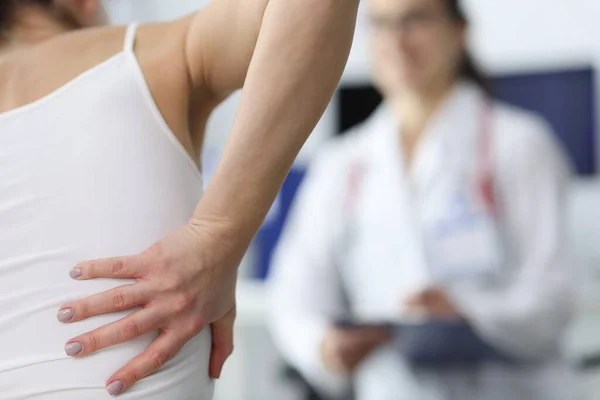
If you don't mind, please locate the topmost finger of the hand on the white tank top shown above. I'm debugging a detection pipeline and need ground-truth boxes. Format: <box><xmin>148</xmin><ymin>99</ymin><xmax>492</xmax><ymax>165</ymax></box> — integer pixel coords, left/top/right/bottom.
<box><xmin>69</xmin><ymin>253</ymin><xmax>148</xmax><ymax>280</ymax></box>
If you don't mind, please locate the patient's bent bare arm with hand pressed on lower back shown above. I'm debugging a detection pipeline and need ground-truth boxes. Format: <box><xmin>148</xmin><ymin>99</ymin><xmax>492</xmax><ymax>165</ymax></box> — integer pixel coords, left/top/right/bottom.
<box><xmin>61</xmin><ymin>0</ymin><xmax>359</xmax><ymax>393</ymax></box>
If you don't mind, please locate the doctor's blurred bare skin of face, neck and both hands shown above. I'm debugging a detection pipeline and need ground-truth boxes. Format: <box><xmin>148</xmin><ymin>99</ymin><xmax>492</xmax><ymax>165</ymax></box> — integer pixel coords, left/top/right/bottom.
<box><xmin>321</xmin><ymin>0</ymin><xmax>466</xmax><ymax>374</ymax></box>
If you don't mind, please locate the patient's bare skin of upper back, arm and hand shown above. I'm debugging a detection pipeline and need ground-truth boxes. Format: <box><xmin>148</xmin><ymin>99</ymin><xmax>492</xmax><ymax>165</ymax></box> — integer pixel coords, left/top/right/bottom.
<box><xmin>0</xmin><ymin>0</ymin><xmax>358</xmax><ymax>394</ymax></box>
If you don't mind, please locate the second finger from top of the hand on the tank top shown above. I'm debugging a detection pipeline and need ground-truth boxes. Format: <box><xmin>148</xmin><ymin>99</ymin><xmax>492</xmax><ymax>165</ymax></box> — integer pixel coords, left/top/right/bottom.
<box><xmin>57</xmin><ymin>283</ymin><xmax>154</xmax><ymax>323</ymax></box>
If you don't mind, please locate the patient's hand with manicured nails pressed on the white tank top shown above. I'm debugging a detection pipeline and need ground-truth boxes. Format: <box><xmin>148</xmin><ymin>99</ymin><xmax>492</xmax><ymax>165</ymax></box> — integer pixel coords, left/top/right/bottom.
<box><xmin>58</xmin><ymin>220</ymin><xmax>244</xmax><ymax>395</ymax></box>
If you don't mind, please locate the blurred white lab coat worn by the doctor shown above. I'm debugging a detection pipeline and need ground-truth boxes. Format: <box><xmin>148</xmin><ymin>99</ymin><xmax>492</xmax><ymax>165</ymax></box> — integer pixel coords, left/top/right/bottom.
<box><xmin>269</xmin><ymin>82</ymin><xmax>579</xmax><ymax>400</ymax></box>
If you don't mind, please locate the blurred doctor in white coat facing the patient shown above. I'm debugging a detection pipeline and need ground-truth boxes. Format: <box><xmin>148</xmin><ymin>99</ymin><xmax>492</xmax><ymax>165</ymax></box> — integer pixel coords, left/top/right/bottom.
<box><xmin>270</xmin><ymin>0</ymin><xmax>578</xmax><ymax>400</ymax></box>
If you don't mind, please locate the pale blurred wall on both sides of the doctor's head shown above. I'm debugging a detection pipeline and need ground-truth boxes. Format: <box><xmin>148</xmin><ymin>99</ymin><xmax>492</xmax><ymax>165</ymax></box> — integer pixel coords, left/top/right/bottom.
<box><xmin>346</xmin><ymin>0</ymin><xmax>600</xmax><ymax>81</ymax></box>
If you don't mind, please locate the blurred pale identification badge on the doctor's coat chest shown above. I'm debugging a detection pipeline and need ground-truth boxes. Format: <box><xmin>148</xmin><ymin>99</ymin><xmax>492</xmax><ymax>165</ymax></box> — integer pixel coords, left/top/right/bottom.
<box><xmin>427</xmin><ymin>194</ymin><xmax>502</xmax><ymax>280</ymax></box>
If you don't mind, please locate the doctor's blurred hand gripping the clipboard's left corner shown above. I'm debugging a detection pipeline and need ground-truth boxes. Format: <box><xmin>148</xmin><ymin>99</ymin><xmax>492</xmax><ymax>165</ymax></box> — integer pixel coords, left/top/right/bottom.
<box><xmin>321</xmin><ymin>327</ymin><xmax>391</xmax><ymax>374</ymax></box>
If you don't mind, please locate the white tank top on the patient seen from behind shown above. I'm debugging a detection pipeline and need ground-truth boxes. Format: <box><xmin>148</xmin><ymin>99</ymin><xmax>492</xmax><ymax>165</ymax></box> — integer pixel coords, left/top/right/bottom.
<box><xmin>0</xmin><ymin>25</ymin><xmax>213</xmax><ymax>400</ymax></box>
